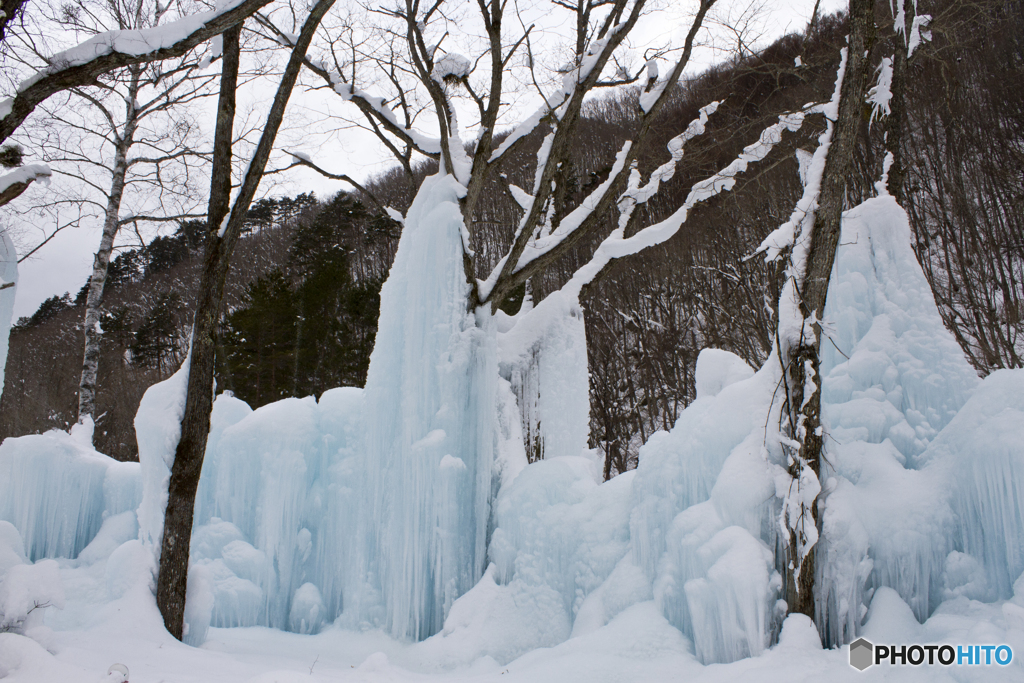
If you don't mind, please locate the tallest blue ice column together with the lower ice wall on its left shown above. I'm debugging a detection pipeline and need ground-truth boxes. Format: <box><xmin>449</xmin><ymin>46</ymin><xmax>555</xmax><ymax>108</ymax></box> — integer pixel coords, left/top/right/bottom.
<box><xmin>193</xmin><ymin>177</ymin><xmax>499</xmax><ymax>640</ymax></box>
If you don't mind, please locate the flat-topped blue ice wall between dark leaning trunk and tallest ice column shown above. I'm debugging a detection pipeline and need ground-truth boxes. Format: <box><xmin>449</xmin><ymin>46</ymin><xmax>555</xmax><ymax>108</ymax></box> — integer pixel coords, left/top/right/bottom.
<box><xmin>191</xmin><ymin>387</ymin><xmax>364</xmax><ymax>633</ymax></box>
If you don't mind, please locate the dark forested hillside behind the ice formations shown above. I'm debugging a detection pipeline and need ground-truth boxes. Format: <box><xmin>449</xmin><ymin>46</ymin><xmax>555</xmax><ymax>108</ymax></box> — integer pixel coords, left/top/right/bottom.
<box><xmin>0</xmin><ymin>0</ymin><xmax>1024</xmax><ymax>477</ymax></box>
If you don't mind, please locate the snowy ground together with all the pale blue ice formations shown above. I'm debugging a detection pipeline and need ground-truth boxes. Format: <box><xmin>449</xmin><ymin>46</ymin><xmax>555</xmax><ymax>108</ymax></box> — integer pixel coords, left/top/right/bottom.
<box><xmin>0</xmin><ymin>189</ymin><xmax>1024</xmax><ymax>683</ymax></box>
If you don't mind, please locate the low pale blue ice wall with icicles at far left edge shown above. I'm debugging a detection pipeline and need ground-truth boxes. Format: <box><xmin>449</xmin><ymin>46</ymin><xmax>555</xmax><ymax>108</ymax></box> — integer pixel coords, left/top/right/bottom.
<box><xmin>0</xmin><ymin>430</ymin><xmax>141</xmax><ymax>561</ymax></box>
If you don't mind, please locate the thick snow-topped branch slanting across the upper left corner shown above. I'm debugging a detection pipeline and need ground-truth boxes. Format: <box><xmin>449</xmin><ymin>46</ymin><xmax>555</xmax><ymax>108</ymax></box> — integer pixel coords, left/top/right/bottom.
<box><xmin>0</xmin><ymin>0</ymin><xmax>270</xmax><ymax>147</ymax></box>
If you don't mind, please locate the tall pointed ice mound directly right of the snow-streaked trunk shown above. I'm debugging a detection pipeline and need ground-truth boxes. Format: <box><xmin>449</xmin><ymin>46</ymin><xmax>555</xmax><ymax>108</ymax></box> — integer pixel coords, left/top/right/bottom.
<box><xmin>818</xmin><ymin>196</ymin><xmax>979</xmax><ymax>643</ymax></box>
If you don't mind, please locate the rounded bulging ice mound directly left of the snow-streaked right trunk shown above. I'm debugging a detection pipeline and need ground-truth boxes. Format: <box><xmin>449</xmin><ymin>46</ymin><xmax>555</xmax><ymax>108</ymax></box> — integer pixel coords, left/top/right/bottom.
<box><xmin>630</xmin><ymin>349</ymin><xmax>781</xmax><ymax>663</ymax></box>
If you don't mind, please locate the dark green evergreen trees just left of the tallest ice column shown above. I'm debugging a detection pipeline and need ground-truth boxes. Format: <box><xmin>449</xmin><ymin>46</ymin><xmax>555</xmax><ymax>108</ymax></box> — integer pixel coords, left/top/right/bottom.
<box><xmin>220</xmin><ymin>194</ymin><xmax>385</xmax><ymax>405</ymax></box>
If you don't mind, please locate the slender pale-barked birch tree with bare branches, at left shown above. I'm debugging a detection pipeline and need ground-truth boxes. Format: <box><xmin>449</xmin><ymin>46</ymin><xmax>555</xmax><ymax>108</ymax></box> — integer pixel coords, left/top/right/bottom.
<box><xmin>9</xmin><ymin>0</ymin><xmax>222</xmax><ymax>434</ymax></box>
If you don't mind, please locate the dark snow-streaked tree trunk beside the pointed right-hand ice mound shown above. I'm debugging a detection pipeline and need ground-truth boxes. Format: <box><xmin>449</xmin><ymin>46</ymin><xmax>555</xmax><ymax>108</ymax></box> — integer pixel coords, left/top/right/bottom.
<box><xmin>786</xmin><ymin>0</ymin><xmax>874</xmax><ymax>618</ymax></box>
